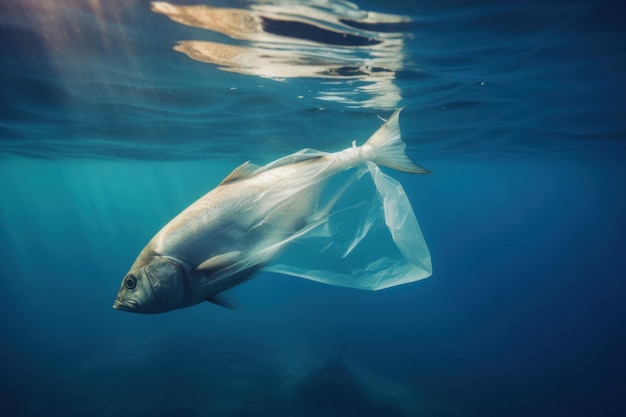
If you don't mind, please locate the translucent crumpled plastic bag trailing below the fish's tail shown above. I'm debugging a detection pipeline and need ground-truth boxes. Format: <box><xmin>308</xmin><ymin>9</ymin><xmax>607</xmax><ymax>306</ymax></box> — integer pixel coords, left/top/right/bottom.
<box><xmin>264</xmin><ymin>162</ymin><xmax>432</xmax><ymax>290</ymax></box>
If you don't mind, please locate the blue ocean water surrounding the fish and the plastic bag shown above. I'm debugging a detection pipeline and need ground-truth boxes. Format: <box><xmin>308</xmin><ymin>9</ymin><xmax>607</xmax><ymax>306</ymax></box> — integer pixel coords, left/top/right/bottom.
<box><xmin>0</xmin><ymin>0</ymin><xmax>626</xmax><ymax>417</ymax></box>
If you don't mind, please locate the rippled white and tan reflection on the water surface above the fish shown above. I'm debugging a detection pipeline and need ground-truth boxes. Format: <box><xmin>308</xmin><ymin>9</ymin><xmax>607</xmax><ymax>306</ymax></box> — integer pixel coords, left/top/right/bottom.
<box><xmin>152</xmin><ymin>0</ymin><xmax>411</xmax><ymax>109</ymax></box>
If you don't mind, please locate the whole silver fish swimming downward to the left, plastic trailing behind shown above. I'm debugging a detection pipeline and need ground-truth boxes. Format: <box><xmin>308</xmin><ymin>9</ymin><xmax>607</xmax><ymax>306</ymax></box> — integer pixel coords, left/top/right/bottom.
<box><xmin>113</xmin><ymin>109</ymin><xmax>430</xmax><ymax>314</ymax></box>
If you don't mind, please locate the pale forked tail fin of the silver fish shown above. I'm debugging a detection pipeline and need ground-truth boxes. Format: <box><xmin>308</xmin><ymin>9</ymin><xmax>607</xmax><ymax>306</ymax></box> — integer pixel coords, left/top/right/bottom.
<box><xmin>363</xmin><ymin>108</ymin><xmax>430</xmax><ymax>174</ymax></box>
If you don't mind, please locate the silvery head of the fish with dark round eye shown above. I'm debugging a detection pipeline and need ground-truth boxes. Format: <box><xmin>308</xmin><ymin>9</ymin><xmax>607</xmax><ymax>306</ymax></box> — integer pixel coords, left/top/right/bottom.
<box><xmin>113</xmin><ymin>255</ymin><xmax>186</xmax><ymax>314</ymax></box>
